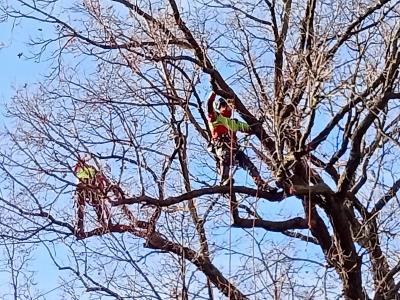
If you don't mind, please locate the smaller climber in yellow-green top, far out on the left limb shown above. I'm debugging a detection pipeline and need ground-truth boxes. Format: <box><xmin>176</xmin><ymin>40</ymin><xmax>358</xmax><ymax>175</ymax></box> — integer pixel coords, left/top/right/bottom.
<box><xmin>74</xmin><ymin>158</ymin><xmax>111</xmax><ymax>238</ymax></box>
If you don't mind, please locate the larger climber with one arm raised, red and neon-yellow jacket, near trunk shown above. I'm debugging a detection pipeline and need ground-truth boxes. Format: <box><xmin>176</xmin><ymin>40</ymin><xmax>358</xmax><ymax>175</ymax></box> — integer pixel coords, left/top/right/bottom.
<box><xmin>207</xmin><ymin>91</ymin><xmax>276</xmax><ymax>192</ymax></box>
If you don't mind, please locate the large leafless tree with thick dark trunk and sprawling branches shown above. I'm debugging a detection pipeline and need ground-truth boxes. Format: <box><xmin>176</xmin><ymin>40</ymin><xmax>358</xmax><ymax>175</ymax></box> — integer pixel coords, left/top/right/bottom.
<box><xmin>0</xmin><ymin>0</ymin><xmax>400</xmax><ymax>300</ymax></box>
